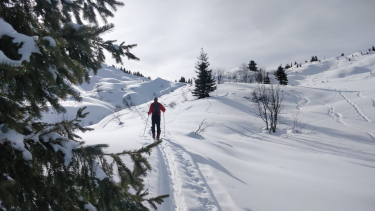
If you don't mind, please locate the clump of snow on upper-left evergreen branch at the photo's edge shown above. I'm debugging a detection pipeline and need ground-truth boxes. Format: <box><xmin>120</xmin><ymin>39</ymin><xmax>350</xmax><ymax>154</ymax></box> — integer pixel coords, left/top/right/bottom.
<box><xmin>0</xmin><ymin>18</ymin><xmax>40</xmax><ymax>67</ymax></box>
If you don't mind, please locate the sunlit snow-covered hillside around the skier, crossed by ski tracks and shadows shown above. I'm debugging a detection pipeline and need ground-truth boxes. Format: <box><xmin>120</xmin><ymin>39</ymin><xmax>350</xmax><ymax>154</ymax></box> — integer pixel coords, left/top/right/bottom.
<box><xmin>69</xmin><ymin>53</ymin><xmax>375</xmax><ymax>211</ymax></box>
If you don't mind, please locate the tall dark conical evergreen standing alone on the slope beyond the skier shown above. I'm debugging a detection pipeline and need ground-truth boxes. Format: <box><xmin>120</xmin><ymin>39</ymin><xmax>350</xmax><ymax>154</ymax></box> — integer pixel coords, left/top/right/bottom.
<box><xmin>193</xmin><ymin>48</ymin><xmax>216</xmax><ymax>99</ymax></box>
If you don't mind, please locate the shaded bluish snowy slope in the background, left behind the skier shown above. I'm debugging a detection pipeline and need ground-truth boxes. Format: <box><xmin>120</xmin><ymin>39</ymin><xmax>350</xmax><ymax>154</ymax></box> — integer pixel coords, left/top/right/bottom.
<box><xmin>44</xmin><ymin>64</ymin><xmax>183</xmax><ymax>126</ymax></box>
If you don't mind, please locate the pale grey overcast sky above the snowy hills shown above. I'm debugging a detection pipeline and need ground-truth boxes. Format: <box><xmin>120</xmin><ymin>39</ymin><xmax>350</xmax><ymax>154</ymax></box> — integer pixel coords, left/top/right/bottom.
<box><xmin>105</xmin><ymin>0</ymin><xmax>375</xmax><ymax>81</ymax></box>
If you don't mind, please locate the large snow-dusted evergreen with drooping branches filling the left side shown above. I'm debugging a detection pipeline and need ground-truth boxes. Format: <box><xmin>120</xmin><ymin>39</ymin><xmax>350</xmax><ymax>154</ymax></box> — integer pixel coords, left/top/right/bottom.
<box><xmin>0</xmin><ymin>0</ymin><xmax>167</xmax><ymax>211</ymax></box>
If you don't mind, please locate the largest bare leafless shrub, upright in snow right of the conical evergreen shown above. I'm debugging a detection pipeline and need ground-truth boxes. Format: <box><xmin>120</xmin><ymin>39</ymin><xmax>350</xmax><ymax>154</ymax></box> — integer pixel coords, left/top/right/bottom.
<box><xmin>251</xmin><ymin>84</ymin><xmax>284</xmax><ymax>133</ymax></box>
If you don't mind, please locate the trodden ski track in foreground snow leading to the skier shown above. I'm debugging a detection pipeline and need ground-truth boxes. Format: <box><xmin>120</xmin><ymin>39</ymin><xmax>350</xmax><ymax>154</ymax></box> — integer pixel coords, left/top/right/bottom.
<box><xmin>159</xmin><ymin>139</ymin><xmax>221</xmax><ymax>211</ymax></box>
